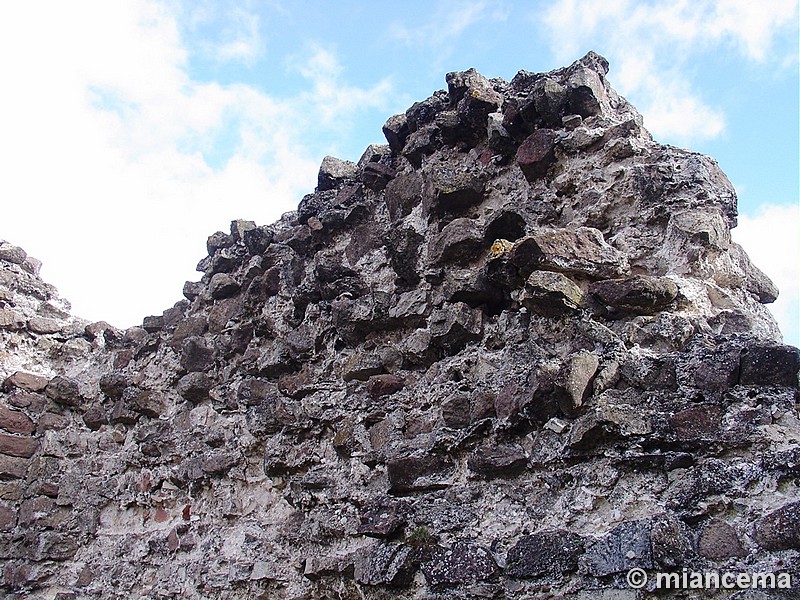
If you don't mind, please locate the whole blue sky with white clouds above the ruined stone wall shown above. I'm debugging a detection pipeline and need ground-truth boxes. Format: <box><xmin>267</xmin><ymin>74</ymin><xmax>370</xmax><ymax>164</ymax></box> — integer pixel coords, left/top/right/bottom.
<box><xmin>0</xmin><ymin>0</ymin><xmax>800</xmax><ymax>344</ymax></box>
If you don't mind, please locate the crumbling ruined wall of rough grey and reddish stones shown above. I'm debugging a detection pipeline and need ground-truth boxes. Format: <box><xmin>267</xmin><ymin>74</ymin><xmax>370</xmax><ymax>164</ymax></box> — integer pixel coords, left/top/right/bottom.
<box><xmin>0</xmin><ymin>53</ymin><xmax>800</xmax><ymax>600</ymax></box>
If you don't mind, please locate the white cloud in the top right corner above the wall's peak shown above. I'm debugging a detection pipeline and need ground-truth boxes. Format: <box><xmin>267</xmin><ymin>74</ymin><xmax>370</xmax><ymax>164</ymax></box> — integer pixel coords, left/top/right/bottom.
<box><xmin>531</xmin><ymin>0</ymin><xmax>797</xmax><ymax>143</ymax></box>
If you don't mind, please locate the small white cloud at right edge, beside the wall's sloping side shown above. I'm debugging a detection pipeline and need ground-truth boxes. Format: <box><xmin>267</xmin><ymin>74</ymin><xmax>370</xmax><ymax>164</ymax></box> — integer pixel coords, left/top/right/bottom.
<box><xmin>731</xmin><ymin>204</ymin><xmax>800</xmax><ymax>346</ymax></box>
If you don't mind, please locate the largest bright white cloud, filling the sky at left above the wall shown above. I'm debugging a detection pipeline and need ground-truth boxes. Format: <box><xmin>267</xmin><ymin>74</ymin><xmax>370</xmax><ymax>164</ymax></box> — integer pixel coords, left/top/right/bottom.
<box><xmin>0</xmin><ymin>0</ymin><xmax>390</xmax><ymax>326</ymax></box>
